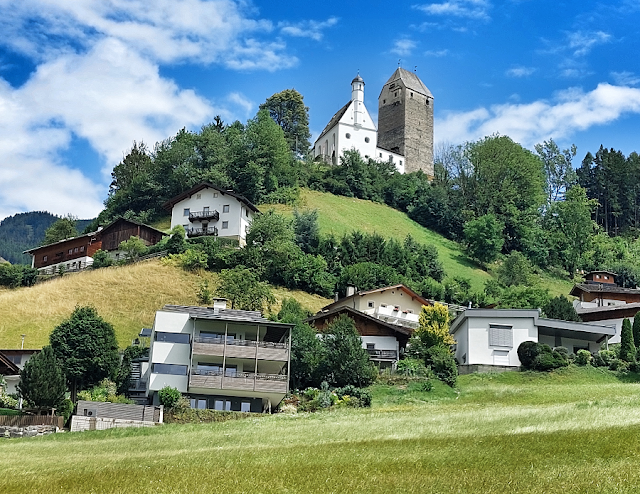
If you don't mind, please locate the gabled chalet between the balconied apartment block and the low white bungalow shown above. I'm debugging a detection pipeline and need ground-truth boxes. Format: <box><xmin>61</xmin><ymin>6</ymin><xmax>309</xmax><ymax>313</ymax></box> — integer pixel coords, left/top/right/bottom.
<box><xmin>307</xmin><ymin>285</ymin><xmax>431</xmax><ymax>367</ymax></box>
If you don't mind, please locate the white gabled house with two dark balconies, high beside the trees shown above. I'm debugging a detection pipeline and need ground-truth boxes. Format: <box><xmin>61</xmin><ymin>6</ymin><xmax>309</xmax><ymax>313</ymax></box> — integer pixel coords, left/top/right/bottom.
<box><xmin>163</xmin><ymin>182</ymin><xmax>260</xmax><ymax>247</ymax></box>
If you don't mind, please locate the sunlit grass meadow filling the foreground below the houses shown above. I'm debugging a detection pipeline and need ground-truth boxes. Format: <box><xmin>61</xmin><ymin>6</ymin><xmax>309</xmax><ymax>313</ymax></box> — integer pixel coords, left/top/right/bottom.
<box><xmin>0</xmin><ymin>368</ymin><xmax>640</xmax><ymax>494</ymax></box>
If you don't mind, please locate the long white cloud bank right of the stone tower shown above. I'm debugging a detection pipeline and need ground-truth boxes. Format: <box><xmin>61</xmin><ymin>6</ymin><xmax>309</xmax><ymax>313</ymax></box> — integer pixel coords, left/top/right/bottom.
<box><xmin>435</xmin><ymin>83</ymin><xmax>640</xmax><ymax>147</ymax></box>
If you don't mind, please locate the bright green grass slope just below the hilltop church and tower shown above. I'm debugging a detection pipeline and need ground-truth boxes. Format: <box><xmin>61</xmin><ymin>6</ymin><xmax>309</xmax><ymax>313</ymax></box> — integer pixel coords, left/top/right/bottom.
<box><xmin>260</xmin><ymin>190</ymin><xmax>572</xmax><ymax>296</ymax></box>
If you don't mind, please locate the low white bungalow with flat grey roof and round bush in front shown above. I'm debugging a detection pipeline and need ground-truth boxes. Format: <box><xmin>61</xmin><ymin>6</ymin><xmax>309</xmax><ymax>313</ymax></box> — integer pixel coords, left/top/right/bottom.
<box><xmin>450</xmin><ymin>309</ymin><xmax>616</xmax><ymax>374</ymax></box>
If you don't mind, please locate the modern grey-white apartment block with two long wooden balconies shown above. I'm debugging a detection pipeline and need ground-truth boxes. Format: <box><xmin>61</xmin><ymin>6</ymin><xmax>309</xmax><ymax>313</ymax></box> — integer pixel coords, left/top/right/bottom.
<box><xmin>142</xmin><ymin>300</ymin><xmax>293</xmax><ymax>413</ymax></box>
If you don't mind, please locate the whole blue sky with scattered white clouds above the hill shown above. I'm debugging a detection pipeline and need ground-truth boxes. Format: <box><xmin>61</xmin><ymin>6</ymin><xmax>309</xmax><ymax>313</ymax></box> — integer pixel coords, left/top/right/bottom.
<box><xmin>0</xmin><ymin>0</ymin><xmax>640</xmax><ymax>218</ymax></box>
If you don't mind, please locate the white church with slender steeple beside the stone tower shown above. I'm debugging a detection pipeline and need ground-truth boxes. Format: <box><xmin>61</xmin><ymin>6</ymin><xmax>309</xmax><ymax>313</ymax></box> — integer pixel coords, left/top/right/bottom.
<box><xmin>313</xmin><ymin>76</ymin><xmax>404</xmax><ymax>173</ymax></box>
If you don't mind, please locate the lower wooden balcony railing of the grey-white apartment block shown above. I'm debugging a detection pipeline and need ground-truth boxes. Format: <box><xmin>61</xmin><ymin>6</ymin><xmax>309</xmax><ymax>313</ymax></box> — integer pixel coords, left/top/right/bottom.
<box><xmin>189</xmin><ymin>370</ymin><xmax>289</xmax><ymax>393</ymax></box>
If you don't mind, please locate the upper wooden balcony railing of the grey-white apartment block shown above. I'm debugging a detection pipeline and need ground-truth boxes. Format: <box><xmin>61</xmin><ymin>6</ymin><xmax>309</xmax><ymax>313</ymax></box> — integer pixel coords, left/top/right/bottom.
<box><xmin>193</xmin><ymin>337</ymin><xmax>289</xmax><ymax>362</ymax></box>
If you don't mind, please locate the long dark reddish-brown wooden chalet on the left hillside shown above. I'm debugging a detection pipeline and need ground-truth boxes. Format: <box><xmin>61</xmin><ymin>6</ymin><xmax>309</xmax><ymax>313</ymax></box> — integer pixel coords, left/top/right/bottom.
<box><xmin>25</xmin><ymin>218</ymin><xmax>164</xmax><ymax>274</ymax></box>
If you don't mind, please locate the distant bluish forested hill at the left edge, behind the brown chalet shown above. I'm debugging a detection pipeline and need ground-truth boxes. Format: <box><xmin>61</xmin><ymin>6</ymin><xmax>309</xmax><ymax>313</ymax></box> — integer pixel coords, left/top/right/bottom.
<box><xmin>0</xmin><ymin>211</ymin><xmax>91</xmax><ymax>264</ymax></box>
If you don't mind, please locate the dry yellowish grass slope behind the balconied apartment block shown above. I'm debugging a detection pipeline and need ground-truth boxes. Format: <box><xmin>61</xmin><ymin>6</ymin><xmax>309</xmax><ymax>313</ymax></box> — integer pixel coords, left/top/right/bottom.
<box><xmin>0</xmin><ymin>260</ymin><xmax>329</xmax><ymax>348</ymax></box>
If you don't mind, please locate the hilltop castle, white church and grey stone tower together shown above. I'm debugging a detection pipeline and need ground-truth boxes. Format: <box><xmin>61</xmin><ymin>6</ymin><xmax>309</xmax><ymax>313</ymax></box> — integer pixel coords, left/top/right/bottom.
<box><xmin>313</xmin><ymin>68</ymin><xmax>433</xmax><ymax>177</ymax></box>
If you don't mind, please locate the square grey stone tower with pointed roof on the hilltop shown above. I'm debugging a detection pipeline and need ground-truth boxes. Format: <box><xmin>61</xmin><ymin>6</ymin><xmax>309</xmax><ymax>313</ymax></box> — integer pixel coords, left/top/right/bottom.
<box><xmin>378</xmin><ymin>68</ymin><xmax>433</xmax><ymax>177</ymax></box>
